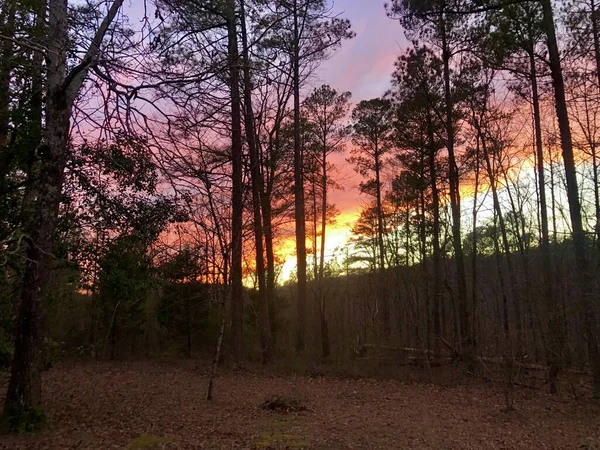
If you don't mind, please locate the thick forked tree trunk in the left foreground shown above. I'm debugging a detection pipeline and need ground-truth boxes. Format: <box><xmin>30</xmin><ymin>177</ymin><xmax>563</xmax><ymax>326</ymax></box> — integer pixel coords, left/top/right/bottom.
<box><xmin>4</xmin><ymin>0</ymin><xmax>123</xmax><ymax>427</ymax></box>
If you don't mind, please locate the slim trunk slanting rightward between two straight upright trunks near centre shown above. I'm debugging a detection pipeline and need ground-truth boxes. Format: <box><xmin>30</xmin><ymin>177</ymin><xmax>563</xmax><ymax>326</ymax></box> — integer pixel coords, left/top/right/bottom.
<box><xmin>240</xmin><ymin>0</ymin><xmax>272</xmax><ymax>364</ymax></box>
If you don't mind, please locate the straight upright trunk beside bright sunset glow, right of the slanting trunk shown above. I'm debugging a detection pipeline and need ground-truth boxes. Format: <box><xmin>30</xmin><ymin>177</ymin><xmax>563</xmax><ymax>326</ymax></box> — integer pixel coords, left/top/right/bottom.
<box><xmin>293</xmin><ymin>0</ymin><xmax>306</xmax><ymax>353</ymax></box>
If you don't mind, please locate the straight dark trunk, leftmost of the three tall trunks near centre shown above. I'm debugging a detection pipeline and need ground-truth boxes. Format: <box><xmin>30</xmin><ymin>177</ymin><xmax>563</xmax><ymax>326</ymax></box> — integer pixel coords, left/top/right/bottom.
<box><xmin>227</xmin><ymin>0</ymin><xmax>244</xmax><ymax>367</ymax></box>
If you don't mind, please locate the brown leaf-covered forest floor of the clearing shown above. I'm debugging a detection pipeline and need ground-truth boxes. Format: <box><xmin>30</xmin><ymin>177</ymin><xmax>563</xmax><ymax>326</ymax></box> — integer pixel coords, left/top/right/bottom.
<box><xmin>0</xmin><ymin>361</ymin><xmax>600</xmax><ymax>450</ymax></box>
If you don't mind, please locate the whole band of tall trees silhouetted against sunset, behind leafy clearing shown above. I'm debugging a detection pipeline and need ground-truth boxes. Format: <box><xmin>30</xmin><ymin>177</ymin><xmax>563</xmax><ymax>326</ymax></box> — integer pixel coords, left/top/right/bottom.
<box><xmin>0</xmin><ymin>0</ymin><xmax>600</xmax><ymax>430</ymax></box>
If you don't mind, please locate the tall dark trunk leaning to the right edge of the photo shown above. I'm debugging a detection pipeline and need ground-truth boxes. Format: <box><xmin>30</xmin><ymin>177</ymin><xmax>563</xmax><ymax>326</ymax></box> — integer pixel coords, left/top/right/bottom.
<box><xmin>541</xmin><ymin>0</ymin><xmax>600</xmax><ymax>397</ymax></box>
